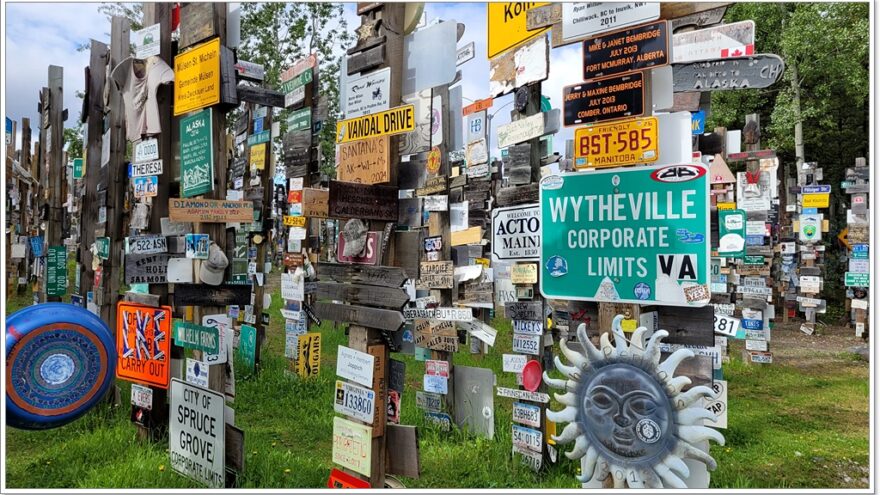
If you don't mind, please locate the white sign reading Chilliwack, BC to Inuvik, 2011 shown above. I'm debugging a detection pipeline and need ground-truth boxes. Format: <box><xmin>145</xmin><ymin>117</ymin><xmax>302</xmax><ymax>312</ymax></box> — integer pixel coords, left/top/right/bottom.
<box><xmin>562</xmin><ymin>2</ymin><xmax>660</xmax><ymax>42</ymax></box>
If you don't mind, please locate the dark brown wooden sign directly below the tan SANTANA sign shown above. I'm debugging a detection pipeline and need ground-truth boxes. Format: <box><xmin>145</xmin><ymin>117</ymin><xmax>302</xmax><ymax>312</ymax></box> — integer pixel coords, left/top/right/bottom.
<box><xmin>329</xmin><ymin>180</ymin><xmax>398</xmax><ymax>222</ymax></box>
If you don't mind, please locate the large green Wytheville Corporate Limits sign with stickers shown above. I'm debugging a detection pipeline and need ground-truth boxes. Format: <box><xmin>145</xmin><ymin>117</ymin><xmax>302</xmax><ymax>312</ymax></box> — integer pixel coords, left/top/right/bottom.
<box><xmin>540</xmin><ymin>164</ymin><xmax>710</xmax><ymax>306</ymax></box>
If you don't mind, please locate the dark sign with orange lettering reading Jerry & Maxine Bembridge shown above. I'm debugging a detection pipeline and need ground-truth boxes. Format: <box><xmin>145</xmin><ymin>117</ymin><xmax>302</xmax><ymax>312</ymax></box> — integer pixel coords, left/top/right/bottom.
<box><xmin>562</xmin><ymin>72</ymin><xmax>645</xmax><ymax>127</ymax></box>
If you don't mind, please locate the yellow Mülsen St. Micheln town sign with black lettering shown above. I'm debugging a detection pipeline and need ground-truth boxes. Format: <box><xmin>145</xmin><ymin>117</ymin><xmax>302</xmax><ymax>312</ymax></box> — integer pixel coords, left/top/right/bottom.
<box><xmin>174</xmin><ymin>38</ymin><xmax>220</xmax><ymax>115</ymax></box>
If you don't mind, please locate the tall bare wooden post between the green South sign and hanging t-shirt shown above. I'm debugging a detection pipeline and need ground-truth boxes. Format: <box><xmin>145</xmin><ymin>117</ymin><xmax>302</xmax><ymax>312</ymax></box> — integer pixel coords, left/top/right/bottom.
<box><xmin>79</xmin><ymin>40</ymin><xmax>110</xmax><ymax>310</ymax></box>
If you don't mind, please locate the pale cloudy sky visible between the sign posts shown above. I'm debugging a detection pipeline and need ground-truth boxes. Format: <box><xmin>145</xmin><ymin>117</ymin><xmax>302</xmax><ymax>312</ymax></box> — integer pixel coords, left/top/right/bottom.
<box><xmin>4</xmin><ymin>3</ymin><xmax>581</xmax><ymax>156</ymax></box>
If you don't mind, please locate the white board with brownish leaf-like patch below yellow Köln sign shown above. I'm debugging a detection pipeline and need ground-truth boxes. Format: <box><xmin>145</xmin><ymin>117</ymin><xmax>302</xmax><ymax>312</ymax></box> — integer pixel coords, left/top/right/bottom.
<box><xmin>489</xmin><ymin>36</ymin><xmax>550</xmax><ymax>98</ymax></box>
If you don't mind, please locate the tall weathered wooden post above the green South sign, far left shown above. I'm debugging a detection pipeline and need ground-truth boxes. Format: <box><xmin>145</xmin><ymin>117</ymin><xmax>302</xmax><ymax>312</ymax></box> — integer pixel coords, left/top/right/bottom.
<box><xmin>43</xmin><ymin>65</ymin><xmax>64</xmax><ymax>302</ymax></box>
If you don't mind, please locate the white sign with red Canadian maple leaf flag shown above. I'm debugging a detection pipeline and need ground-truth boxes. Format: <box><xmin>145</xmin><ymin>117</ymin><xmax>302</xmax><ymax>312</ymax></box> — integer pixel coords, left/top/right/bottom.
<box><xmin>672</xmin><ymin>20</ymin><xmax>755</xmax><ymax>63</ymax></box>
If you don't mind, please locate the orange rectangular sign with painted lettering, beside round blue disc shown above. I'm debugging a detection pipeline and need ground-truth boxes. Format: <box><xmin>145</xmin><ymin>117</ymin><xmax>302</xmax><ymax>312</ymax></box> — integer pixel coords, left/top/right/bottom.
<box><xmin>116</xmin><ymin>302</ymin><xmax>171</xmax><ymax>389</ymax></box>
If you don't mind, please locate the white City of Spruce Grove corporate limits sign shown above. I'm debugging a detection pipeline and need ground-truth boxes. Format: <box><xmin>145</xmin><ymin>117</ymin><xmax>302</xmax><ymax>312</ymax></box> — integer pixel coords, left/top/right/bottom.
<box><xmin>168</xmin><ymin>378</ymin><xmax>226</xmax><ymax>488</ymax></box>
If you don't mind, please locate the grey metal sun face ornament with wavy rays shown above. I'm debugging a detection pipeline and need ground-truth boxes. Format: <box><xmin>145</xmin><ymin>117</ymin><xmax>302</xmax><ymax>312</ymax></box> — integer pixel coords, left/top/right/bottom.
<box><xmin>544</xmin><ymin>315</ymin><xmax>724</xmax><ymax>488</ymax></box>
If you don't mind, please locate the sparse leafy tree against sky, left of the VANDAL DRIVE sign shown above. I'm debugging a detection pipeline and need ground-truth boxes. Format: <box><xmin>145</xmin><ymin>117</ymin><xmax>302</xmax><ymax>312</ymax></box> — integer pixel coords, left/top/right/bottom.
<box><xmin>239</xmin><ymin>3</ymin><xmax>353</xmax><ymax>175</ymax></box>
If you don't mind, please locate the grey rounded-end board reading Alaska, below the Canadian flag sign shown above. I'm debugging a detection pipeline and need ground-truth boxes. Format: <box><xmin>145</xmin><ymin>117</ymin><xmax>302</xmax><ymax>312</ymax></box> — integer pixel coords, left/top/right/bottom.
<box><xmin>672</xmin><ymin>54</ymin><xmax>785</xmax><ymax>93</ymax></box>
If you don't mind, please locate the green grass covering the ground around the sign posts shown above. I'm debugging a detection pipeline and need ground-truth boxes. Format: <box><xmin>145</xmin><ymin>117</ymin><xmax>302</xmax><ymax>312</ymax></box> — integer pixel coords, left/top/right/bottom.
<box><xmin>6</xmin><ymin>293</ymin><xmax>868</xmax><ymax>488</ymax></box>
